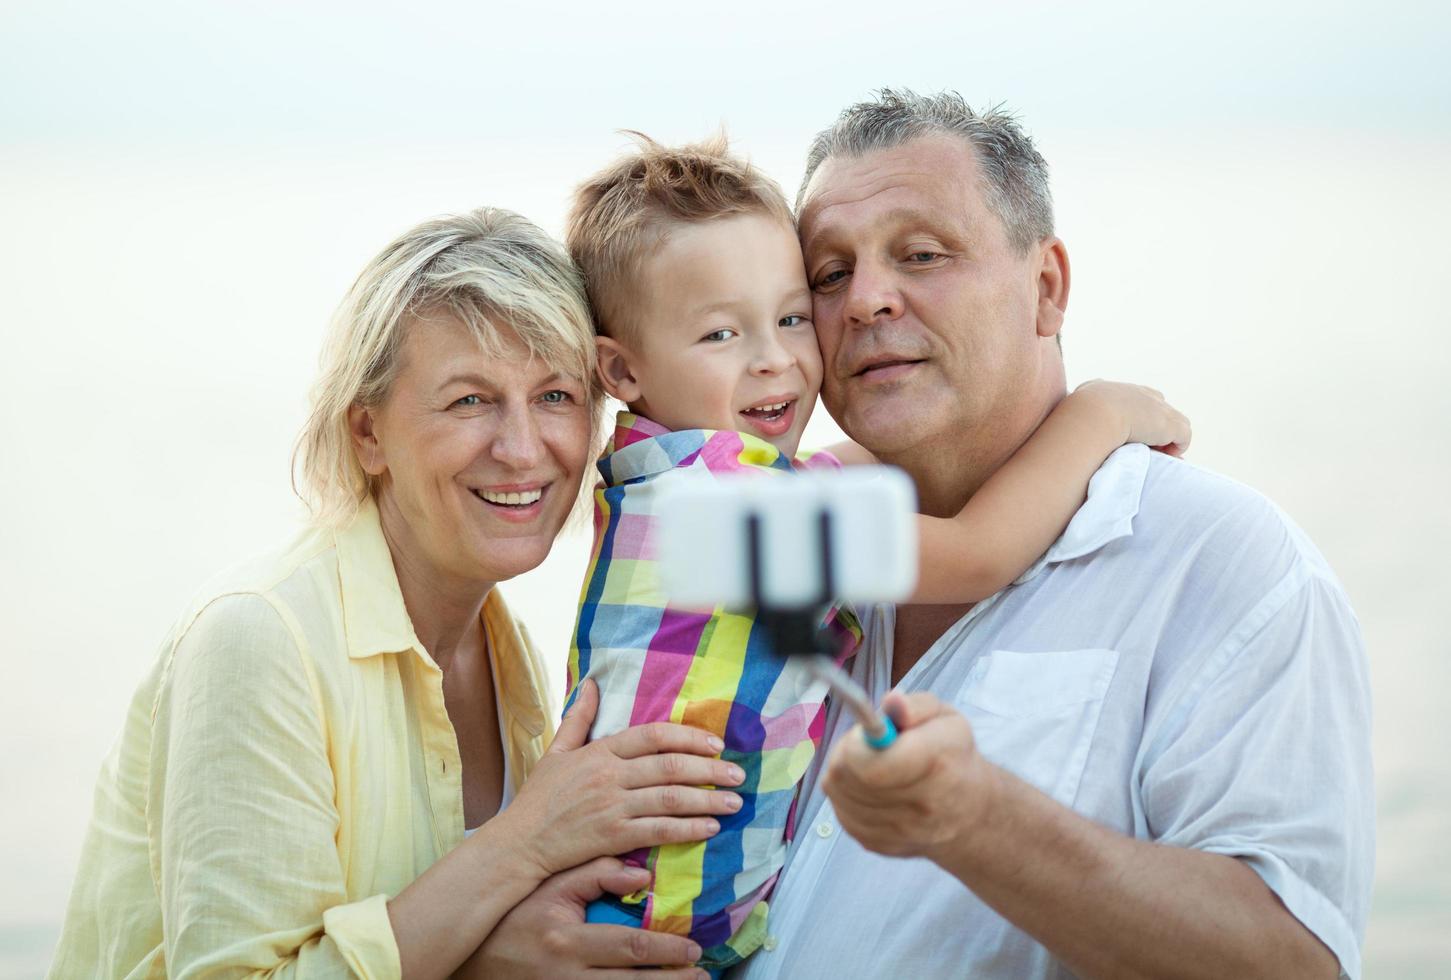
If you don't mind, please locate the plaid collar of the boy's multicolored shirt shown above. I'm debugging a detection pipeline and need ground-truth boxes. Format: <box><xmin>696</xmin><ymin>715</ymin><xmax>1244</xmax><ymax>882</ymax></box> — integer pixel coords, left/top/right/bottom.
<box><xmin>598</xmin><ymin>412</ymin><xmax>792</xmax><ymax>486</ymax></box>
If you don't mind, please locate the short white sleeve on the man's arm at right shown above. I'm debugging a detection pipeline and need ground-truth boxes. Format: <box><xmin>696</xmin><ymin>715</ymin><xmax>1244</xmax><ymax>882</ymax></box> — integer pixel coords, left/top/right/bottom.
<box><xmin>1139</xmin><ymin>565</ymin><xmax>1376</xmax><ymax>979</ymax></box>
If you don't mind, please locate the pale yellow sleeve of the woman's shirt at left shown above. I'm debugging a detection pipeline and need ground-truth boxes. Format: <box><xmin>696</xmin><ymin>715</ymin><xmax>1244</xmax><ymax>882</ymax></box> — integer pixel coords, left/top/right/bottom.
<box><xmin>148</xmin><ymin>595</ymin><xmax>402</xmax><ymax>979</ymax></box>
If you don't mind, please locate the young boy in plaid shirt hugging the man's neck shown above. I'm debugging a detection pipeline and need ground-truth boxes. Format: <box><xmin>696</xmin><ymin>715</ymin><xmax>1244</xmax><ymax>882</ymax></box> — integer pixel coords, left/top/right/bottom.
<box><xmin>566</xmin><ymin>138</ymin><xmax>1188</xmax><ymax>974</ymax></box>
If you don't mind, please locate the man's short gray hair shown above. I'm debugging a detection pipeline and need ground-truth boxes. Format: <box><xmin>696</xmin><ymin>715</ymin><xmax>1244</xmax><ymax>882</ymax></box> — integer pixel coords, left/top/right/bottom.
<box><xmin>797</xmin><ymin>89</ymin><xmax>1053</xmax><ymax>251</ymax></box>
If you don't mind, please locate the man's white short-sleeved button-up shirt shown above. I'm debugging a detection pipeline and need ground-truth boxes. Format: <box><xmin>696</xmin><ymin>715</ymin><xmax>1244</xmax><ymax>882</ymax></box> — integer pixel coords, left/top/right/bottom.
<box><xmin>734</xmin><ymin>446</ymin><xmax>1374</xmax><ymax>980</ymax></box>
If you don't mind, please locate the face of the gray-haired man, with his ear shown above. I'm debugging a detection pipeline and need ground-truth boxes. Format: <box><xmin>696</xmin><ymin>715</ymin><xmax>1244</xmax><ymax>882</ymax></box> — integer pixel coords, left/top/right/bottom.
<box><xmin>800</xmin><ymin>136</ymin><xmax>1061</xmax><ymax>459</ymax></box>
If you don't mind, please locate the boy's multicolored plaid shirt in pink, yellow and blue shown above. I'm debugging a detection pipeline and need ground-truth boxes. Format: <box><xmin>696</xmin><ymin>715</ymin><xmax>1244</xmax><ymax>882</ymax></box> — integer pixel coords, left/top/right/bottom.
<box><xmin>564</xmin><ymin>412</ymin><xmax>862</xmax><ymax>967</ymax></box>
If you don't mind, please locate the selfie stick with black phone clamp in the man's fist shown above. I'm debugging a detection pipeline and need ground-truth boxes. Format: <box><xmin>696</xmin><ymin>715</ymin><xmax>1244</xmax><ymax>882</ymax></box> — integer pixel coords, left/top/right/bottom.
<box><xmin>746</xmin><ymin>510</ymin><xmax>897</xmax><ymax>749</ymax></box>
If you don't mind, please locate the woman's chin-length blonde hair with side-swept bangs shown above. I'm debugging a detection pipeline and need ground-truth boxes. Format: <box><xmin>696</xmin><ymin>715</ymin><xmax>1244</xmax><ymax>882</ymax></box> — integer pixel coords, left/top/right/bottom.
<box><xmin>293</xmin><ymin>208</ymin><xmax>602</xmax><ymax>526</ymax></box>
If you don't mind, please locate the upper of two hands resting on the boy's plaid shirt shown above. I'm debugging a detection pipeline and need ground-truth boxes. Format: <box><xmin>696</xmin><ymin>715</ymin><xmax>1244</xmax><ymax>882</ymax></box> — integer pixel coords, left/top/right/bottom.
<box><xmin>490</xmin><ymin>679</ymin><xmax>746</xmax><ymax>880</ymax></box>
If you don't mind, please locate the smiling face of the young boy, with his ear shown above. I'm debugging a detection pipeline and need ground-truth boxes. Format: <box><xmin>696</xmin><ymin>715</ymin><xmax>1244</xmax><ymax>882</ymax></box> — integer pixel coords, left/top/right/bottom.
<box><xmin>598</xmin><ymin>213</ymin><xmax>821</xmax><ymax>456</ymax></box>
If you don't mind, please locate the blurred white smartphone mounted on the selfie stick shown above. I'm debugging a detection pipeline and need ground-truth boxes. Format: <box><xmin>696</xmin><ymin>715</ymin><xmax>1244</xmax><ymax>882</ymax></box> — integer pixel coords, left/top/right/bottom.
<box><xmin>656</xmin><ymin>466</ymin><xmax>917</xmax><ymax>610</ymax></box>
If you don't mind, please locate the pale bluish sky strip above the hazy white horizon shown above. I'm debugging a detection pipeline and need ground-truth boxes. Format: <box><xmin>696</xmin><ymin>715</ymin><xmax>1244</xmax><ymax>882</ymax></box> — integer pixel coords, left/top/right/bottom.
<box><xmin>0</xmin><ymin>0</ymin><xmax>1451</xmax><ymax>148</ymax></box>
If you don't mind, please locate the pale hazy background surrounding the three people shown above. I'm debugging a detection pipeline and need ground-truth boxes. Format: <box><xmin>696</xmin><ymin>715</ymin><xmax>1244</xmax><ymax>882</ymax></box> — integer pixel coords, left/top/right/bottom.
<box><xmin>0</xmin><ymin>0</ymin><xmax>1451</xmax><ymax>979</ymax></box>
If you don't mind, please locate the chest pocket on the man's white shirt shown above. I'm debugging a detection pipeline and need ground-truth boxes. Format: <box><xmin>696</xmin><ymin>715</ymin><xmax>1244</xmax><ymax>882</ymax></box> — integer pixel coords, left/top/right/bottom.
<box><xmin>959</xmin><ymin>650</ymin><xmax>1119</xmax><ymax>806</ymax></box>
